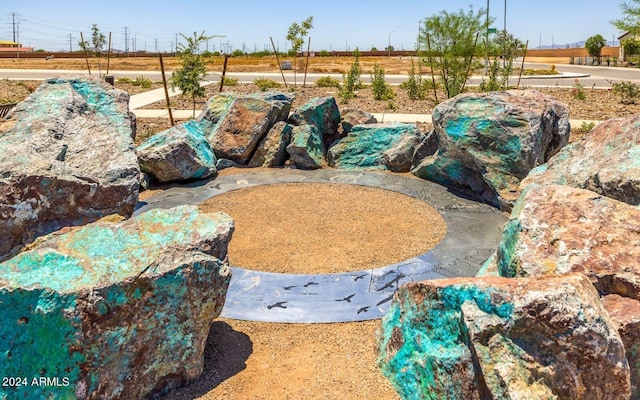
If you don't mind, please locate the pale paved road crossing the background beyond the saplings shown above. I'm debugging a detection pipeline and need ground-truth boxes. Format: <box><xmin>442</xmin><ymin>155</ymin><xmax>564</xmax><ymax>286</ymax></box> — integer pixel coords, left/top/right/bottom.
<box><xmin>0</xmin><ymin>63</ymin><xmax>640</xmax><ymax>88</ymax></box>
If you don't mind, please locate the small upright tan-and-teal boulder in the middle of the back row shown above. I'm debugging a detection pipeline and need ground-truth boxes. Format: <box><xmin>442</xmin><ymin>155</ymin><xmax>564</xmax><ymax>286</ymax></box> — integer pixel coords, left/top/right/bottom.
<box><xmin>287</xmin><ymin>124</ymin><xmax>325</xmax><ymax>169</ymax></box>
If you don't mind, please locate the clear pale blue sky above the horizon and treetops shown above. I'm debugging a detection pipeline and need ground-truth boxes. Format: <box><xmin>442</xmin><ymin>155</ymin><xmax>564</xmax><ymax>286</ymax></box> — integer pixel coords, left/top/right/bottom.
<box><xmin>0</xmin><ymin>0</ymin><xmax>623</xmax><ymax>52</ymax></box>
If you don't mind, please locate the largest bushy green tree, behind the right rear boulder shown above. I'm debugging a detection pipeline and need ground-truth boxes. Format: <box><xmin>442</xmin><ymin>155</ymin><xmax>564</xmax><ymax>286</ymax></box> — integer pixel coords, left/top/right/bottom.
<box><xmin>418</xmin><ymin>6</ymin><xmax>488</xmax><ymax>98</ymax></box>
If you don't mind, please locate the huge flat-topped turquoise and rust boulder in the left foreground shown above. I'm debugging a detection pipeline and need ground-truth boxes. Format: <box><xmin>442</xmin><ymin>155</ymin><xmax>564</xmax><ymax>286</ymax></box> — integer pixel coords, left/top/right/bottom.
<box><xmin>0</xmin><ymin>206</ymin><xmax>233</xmax><ymax>399</ymax></box>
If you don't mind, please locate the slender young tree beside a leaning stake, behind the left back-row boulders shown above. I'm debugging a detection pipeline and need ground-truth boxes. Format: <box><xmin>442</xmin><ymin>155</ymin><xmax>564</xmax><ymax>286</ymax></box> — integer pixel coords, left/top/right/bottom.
<box><xmin>169</xmin><ymin>31</ymin><xmax>213</xmax><ymax>118</ymax></box>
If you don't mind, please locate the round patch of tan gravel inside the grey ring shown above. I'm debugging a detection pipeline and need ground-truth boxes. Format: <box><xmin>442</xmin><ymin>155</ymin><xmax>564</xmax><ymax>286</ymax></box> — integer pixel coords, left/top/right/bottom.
<box><xmin>200</xmin><ymin>183</ymin><xmax>447</xmax><ymax>274</ymax></box>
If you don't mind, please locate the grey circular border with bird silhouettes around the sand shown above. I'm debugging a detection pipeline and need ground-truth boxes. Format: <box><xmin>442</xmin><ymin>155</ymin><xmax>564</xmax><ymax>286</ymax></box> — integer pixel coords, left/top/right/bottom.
<box><xmin>134</xmin><ymin>169</ymin><xmax>507</xmax><ymax>323</ymax></box>
